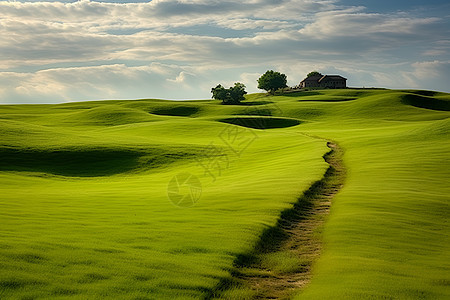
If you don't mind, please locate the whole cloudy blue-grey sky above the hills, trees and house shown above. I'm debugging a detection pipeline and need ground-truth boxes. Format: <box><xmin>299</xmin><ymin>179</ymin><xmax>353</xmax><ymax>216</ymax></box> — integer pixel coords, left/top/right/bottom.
<box><xmin>0</xmin><ymin>0</ymin><xmax>450</xmax><ymax>104</ymax></box>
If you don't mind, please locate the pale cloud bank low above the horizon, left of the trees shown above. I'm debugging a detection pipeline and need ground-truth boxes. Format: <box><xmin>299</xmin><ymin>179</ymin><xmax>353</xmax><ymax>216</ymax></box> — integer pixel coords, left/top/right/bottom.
<box><xmin>0</xmin><ymin>63</ymin><xmax>239</xmax><ymax>103</ymax></box>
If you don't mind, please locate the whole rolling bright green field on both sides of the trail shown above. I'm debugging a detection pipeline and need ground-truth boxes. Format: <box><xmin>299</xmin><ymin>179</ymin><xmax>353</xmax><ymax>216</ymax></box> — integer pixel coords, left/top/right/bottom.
<box><xmin>0</xmin><ymin>89</ymin><xmax>450</xmax><ymax>299</ymax></box>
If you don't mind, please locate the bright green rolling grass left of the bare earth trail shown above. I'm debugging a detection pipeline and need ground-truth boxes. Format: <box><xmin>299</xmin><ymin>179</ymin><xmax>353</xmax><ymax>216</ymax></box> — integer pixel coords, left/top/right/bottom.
<box><xmin>0</xmin><ymin>100</ymin><xmax>326</xmax><ymax>299</ymax></box>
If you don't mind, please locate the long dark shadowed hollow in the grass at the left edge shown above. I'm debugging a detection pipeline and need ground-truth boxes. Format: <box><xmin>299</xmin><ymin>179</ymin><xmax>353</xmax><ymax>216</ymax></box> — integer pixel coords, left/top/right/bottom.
<box><xmin>0</xmin><ymin>148</ymin><xmax>198</xmax><ymax>177</ymax></box>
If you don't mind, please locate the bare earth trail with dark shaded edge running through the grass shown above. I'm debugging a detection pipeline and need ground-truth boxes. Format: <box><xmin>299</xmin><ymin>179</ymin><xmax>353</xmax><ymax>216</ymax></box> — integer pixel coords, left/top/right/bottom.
<box><xmin>206</xmin><ymin>142</ymin><xmax>345</xmax><ymax>299</ymax></box>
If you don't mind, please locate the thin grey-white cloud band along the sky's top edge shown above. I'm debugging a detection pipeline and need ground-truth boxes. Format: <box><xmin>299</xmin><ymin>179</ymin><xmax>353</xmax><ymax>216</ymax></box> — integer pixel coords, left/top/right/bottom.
<box><xmin>0</xmin><ymin>0</ymin><xmax>333</xmax><ymax>23</ymax></box>
